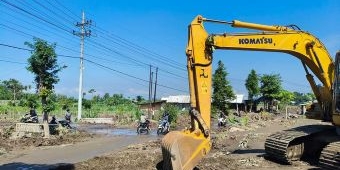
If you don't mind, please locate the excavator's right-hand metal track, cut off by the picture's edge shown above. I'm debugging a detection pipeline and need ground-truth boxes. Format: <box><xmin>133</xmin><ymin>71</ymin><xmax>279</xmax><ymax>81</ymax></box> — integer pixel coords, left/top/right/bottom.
<box><xmin>319</xmin><ymin>142</ymin><xmax>340</xmax><ymax>170</ymax></box>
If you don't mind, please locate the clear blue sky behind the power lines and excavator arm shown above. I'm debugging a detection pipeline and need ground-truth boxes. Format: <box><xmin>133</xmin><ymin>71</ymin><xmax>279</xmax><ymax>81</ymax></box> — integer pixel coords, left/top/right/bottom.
<box><xmin>0</xmin><ymin>0</ymin><xmax>340</xmax><ymax>98</ymax></box>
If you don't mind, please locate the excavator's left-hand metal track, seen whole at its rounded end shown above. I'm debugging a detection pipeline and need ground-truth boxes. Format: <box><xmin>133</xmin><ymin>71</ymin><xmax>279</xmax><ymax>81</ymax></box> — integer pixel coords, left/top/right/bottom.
<box><xmin>264</xmin><ymin>125</ymin><xmax>334</xmax><ymax>164</ymax></box>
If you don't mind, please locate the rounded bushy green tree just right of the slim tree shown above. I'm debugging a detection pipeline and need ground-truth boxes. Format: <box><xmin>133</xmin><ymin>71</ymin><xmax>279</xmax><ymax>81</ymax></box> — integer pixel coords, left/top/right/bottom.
<box><xmin>260</xmin><ymin>74</ymin><xmax>282</xmax><ymax>109</ymax></box>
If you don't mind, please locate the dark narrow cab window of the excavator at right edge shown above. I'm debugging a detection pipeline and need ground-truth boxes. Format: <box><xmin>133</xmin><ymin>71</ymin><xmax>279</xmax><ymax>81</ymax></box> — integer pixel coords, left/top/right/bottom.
<box><xmin>334</xmin><ymin>52</ymin><xmax>340</xmax><ymax>114</ymax></box>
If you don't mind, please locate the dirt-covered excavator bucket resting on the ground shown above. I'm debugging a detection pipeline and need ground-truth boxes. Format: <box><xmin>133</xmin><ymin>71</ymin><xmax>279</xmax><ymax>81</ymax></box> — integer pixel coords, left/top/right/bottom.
<box><xmin>162</xmin><ymin>131</ymin><xmax>211</xmax><ymax>170</ymax></box>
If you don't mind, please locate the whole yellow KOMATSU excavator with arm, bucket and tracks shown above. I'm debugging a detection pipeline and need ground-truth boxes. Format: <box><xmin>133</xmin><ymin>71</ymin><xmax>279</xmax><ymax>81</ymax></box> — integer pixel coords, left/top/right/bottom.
<box><xmin>161</xmin><ymin>15</ymin><xmax>340</xmax><ymax>170</ymax></box>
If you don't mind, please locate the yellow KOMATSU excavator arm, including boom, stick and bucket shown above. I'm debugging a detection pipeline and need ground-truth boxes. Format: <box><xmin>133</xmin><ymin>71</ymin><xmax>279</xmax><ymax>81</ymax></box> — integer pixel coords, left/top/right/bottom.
<box><xmin>162</xmin><ymin>16</ymin><xmax>334</xmax><ymax>169</ymax></box>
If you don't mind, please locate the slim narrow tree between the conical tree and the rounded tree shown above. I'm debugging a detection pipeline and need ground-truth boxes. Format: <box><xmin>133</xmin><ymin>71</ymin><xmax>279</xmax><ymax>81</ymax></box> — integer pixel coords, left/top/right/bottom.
<box><xmin>245</xmin><ymin>69</ymin><xmax>260</xmax><ymax>112</ymax></box>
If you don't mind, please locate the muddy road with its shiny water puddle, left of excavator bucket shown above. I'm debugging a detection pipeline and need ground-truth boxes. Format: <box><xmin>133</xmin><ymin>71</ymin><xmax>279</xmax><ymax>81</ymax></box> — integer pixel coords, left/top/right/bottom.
<box><xmin>0</xmin><ymin>124</ymin><xmax>162</xmax><ymax>170</ymax></box>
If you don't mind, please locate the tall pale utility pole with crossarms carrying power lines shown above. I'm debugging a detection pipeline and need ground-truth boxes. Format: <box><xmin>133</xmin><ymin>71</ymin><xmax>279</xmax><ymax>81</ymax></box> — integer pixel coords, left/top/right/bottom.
<box><xmin>73</xmin><ymin>11</ymin><xmax>92</xmax><ymax>120</ymax></box>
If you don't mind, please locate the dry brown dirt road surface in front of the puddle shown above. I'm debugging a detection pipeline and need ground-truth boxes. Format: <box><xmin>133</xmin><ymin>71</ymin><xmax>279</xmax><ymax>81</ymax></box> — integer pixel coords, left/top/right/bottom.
<box><xmin>0</xmin><ymin>135</ymin><xmax>156</xmax><ymax>170</ymax></box>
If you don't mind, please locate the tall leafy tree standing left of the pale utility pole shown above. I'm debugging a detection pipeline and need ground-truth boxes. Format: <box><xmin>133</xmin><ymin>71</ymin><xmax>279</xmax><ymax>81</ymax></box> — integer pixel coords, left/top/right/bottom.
<box><xmin>25</xmin><ymin>38</ymin><xmax>66</xmax><ymax>121</ymax></box>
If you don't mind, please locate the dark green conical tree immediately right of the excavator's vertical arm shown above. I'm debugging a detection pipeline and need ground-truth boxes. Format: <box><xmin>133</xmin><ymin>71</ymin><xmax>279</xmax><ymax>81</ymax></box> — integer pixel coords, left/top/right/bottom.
<box><xmin>212</xmin><ymin>61</ymin><xmax>235</xmax><ymax>112</ymax></box>
